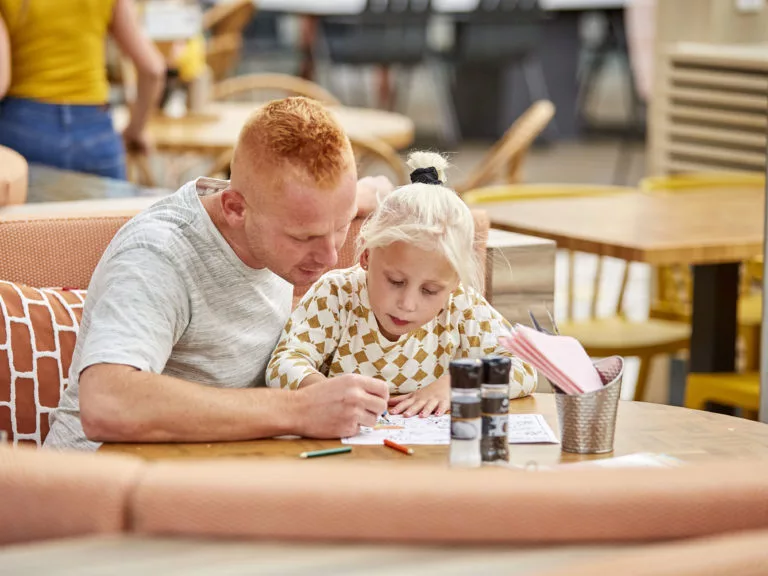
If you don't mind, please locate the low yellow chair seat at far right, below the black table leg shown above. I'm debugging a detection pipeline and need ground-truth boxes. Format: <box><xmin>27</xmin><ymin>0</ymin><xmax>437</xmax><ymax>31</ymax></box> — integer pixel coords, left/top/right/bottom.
<box><xmin>685</xmin><ymin>372</ymin><xmax>760</xmax><ymax>420</ymax></box>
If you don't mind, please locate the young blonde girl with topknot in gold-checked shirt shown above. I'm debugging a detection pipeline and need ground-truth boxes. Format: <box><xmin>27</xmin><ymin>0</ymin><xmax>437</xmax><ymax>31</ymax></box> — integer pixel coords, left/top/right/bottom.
<box><xmin>267</xmin><ymin>152</ymin><xmax>536</xmax><ymax>416</ymax></box>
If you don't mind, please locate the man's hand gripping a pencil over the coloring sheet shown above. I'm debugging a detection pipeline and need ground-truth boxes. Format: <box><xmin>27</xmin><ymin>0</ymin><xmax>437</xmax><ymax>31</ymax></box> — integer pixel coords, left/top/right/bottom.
<box><xmin>294</xmin><ymin>374</ymin><xmax>389</xmax><ymax>438</ymax></box>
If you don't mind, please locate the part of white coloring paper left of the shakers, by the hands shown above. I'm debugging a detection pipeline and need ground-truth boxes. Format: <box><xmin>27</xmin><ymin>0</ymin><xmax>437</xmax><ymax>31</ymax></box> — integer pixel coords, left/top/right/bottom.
<box><xmin>341</xmin><ymin>414</ymin><xmax>451</xmax><ymax>445</ymax></box>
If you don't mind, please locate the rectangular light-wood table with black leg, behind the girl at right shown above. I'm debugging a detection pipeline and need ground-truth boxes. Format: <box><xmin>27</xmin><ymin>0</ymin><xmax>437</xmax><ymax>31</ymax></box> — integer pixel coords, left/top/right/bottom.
<box><xmin>482</xmin><ymin>187</ymin><xmax>765</xmax><ymax>372</ymax></box>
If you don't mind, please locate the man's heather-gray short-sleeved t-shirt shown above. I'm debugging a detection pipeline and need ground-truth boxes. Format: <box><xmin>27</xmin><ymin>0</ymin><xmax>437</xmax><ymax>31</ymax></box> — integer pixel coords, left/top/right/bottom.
<box><xmin>45</xmin><ymin>178</ymin><xmax>293</xmax><ymax>450</ymax></box>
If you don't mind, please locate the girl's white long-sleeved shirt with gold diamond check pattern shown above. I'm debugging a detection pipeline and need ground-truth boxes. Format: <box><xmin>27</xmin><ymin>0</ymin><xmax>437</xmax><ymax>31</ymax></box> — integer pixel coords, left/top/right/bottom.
<box><xmin>267</xmin><ymin>267</ymin><xmax>536</xmax><ymax>397</ymax></box>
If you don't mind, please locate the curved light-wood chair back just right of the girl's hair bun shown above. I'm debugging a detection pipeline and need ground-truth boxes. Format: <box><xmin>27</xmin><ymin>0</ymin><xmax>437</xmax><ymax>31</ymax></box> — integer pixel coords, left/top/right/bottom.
<box><xmin>455</xmin><ymin>100</ymin><xmax>555</xmax><ymax>195</ymax></box>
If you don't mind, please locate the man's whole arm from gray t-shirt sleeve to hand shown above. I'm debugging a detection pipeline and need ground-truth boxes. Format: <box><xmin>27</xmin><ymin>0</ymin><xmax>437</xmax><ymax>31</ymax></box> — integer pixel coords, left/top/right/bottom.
<box><xmin>73</xmin><ymin>249</ymin><xmax>388</xmax><ymax>442</ymax></box>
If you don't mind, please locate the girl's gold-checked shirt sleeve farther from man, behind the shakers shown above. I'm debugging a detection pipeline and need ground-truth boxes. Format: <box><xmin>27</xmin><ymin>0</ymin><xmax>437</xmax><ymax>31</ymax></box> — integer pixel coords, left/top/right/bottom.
<box><xmin>459</xmin><ymin>290</ymin><xmax>538</xmax><ymax>398</ymax></box>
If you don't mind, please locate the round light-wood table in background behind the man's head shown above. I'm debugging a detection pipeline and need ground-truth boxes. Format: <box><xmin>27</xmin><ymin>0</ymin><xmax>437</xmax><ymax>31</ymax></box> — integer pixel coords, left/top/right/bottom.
<box><xmin>113</xmin><ymin>102</ymin><xmax>414</xmax><ymax>154</ymax></box>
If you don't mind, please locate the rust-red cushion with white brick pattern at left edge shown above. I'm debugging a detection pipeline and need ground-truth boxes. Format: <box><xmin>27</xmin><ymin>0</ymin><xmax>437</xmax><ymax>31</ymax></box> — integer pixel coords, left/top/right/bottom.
<box><xmin>0</xmin><ymin>281</ymin><xmax>86</xmax><ymax>446</ymax></box>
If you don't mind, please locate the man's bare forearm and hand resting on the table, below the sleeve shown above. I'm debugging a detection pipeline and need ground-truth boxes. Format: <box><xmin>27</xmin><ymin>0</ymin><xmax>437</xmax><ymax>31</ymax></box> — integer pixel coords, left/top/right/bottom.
<box><xmin>80</xmin><ymin>364</ymin><xmax>389</xmax><ymax>442</ymax></box>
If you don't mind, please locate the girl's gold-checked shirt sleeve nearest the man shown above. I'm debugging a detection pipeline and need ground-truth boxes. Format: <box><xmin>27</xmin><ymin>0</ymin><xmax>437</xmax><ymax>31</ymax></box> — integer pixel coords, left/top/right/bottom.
<box><xmin>267</xmin><ymin>276</ymin><xmax>341</xmax><ymax>390</ymax></box>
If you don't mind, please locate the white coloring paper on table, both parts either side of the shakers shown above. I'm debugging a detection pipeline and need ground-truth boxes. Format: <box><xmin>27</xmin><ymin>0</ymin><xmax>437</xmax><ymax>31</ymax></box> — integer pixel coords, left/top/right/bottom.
<box><xmin>341</xmin><ymin>414</ymin><xmax>559</xmax><ymax>446</ymax></box>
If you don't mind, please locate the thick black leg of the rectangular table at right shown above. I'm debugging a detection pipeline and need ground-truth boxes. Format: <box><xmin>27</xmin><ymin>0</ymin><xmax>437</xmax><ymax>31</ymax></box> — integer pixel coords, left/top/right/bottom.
<box><xmin>690</xmin><ymin>262</ymin><xmax>739</xmax><ymax>372</ymax></box>
